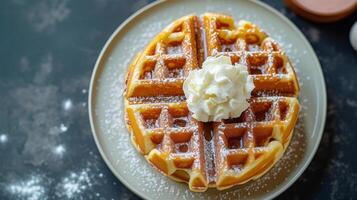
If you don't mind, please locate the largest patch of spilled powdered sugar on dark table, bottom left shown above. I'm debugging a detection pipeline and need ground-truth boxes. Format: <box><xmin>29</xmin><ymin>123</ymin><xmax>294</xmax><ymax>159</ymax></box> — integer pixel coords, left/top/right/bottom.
<box><xmin>5</xmin><ymin>159</ymin><xmax>104</xmax><ymax>200</ymax></box>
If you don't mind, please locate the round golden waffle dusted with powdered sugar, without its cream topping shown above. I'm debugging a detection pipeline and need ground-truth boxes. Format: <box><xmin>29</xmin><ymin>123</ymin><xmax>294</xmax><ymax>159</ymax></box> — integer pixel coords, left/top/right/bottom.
<box><xmin>124</xmin><ymin>13</ymin><xmax>299</xmax><ymax>192</ymax></box>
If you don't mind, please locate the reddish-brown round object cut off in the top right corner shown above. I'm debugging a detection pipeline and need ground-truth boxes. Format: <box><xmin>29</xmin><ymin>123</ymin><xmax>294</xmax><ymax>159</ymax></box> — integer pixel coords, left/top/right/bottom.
<box><xmin>284</xmin><ymin>0</ymin><xmax>357</xmax><ymax>23</ymax></box>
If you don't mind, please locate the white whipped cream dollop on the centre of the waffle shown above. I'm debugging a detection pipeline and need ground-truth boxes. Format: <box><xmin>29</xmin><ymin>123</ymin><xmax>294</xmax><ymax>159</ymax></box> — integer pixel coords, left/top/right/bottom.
<box><xmin>183</xmin><ymin>56</ymin><xmax>254</xmax><ymax>122</ymax></box>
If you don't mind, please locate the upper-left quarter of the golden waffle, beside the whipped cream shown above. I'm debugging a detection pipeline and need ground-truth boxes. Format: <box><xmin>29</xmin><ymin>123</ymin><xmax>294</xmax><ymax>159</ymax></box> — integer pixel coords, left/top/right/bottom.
<box><xmin>127</xmin><ymin>17</ymin><xmax>198</xmax><ymax>97</ymax></box>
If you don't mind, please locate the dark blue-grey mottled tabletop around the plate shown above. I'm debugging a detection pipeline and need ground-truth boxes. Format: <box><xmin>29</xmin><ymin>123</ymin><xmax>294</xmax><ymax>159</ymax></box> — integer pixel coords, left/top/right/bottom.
<box><xmin>0</xmin><ymin>0</ymin><xmax>357</xmax><ymax>200</ymax></box>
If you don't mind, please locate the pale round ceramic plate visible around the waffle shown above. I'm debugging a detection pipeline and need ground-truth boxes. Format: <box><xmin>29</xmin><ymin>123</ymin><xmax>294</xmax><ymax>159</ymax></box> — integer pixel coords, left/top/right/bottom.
<box><xmin>89</xmin><ymin>0</ymin><xmax>326</xmax><ymax>199</ymax></box>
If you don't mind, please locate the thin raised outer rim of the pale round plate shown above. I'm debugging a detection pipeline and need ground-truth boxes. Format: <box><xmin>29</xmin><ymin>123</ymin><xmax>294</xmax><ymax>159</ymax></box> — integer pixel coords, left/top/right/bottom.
<box><xmin>88</xmin><ymin>0</ymin><xmax>327</xmax><ymax>199</ymax></box>
